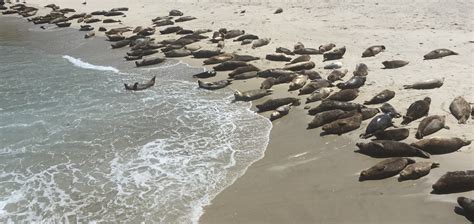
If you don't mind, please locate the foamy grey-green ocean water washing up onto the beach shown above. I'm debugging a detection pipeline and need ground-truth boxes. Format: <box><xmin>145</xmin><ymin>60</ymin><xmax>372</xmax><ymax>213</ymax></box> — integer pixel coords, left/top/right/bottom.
<box><xmin>0</xmin><ymin>18</ymin><xmax>271</xmax><ymax>223</ymax></box>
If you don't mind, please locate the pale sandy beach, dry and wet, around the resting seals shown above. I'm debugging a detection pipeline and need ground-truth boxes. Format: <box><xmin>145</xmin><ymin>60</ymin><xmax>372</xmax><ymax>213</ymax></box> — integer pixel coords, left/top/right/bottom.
<box><xmin>1</xmin><ymin>0</ymin><xmax>474</xmax><ymax>224</ymax></box>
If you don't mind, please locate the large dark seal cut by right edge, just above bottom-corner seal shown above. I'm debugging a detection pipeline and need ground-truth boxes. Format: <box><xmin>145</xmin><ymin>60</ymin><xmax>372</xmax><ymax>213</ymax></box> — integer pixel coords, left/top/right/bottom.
<box><xmin>432</xmin><ymin>170</ymin><xmax>474</xmax><ymax>194</ymax></box>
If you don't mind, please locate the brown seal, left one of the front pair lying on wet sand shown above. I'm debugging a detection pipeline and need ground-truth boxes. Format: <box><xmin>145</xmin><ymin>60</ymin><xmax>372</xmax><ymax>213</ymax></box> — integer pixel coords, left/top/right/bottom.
<box><xmin>359</xmin><ymin>158</ymin><xmax>415</xmax><ymax>181</ymax></box>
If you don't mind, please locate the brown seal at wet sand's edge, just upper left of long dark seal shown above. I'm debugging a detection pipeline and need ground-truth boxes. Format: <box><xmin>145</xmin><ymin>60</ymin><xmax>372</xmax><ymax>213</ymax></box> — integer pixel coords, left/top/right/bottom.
<box><xmin>320</xmin><ymin>113</ymin><xmax>362</xmax><ymax>136</ymax></box>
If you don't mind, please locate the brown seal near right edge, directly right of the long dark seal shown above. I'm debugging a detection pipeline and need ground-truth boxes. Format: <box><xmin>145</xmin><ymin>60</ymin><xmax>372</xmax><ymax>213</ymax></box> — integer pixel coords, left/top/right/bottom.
<box><xmin>411</xmin><ymin>137</ymin><xmax>471</xmax><ymax>155</ymax></box>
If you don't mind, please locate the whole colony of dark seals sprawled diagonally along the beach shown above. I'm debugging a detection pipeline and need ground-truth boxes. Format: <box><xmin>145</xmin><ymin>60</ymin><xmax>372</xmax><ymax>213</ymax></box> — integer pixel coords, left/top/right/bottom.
<box><xmin>3</xmin><ymin>1</ymin><xmax>474</xmax><ymax>222</ymax></box>
